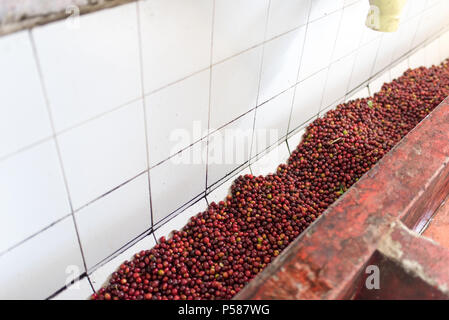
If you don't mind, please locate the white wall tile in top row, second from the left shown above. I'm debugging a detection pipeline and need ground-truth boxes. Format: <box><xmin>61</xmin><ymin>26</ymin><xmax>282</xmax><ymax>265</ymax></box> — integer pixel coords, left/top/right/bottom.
<box><xmin>32</xmin><ymin>3</ymin><xmax>141</xmax><ymax>132</ymax></box>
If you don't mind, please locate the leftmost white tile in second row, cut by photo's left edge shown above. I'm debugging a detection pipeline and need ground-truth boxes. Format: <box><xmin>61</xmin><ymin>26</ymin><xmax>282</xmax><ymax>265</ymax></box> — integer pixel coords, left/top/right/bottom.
<box><xmin>0</xmin><ymin>140</ymin><xmax>70</xmax><ymax>252</ymax></box>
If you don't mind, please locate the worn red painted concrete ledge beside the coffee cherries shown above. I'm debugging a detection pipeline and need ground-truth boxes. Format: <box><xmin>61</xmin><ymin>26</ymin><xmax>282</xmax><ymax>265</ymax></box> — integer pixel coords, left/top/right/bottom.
<box><xmin>235</xmin><ymin>98</ymin><xmax>449</xmax><ymax>299</ymax></box>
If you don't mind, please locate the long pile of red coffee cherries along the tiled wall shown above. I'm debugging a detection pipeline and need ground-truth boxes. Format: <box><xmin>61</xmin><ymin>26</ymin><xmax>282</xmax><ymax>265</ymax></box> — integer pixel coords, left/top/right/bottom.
<box><xmin>92</xmin><ymin>61</ymin><xmax>449</xmax><ymax>300</ymax></box>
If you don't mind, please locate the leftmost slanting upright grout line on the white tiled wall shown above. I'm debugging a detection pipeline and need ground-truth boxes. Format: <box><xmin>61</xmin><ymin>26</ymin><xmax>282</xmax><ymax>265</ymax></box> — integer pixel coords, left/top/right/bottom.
<box><xmin>28</xmin><ymin>30</ymin><xmax>87</xmax><ymax>271</ymax></box>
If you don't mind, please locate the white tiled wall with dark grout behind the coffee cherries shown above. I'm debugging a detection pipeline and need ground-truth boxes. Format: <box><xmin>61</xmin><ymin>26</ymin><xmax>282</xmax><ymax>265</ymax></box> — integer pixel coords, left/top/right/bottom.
<box><xmin>0</xmin><ymin>0</ymin><xmax>449</xmax><ymax>299</ymax></box>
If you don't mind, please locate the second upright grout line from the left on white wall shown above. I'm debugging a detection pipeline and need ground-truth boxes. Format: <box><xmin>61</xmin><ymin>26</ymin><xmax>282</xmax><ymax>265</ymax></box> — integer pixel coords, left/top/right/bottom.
<box><xmin>136</xmin><ymin>1</ymin><xmax>154</xmax><ymax>227</ymax></box>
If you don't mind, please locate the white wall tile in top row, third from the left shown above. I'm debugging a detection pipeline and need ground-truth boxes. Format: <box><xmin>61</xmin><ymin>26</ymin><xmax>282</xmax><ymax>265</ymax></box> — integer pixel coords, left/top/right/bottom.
<box><xmin>139</xmin><ymin>0</ymin><xmax>213</xmax><ymax>93</ymax></box>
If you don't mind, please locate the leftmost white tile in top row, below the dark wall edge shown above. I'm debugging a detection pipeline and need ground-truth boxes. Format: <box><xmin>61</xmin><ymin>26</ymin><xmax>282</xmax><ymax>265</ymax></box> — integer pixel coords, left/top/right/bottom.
<box><xmin>0</xmin><ymin>31</ymin><xmax>52</xmax><ymax>158</ymax></box>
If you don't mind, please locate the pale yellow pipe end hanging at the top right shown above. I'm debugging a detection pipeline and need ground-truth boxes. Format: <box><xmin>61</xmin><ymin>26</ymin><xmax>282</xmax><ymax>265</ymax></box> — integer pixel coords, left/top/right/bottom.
<box><xmin>365</xmin><ymin>0</ymin><xmax>407</xmax><ymax>32</ymax></box>
